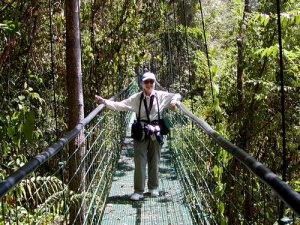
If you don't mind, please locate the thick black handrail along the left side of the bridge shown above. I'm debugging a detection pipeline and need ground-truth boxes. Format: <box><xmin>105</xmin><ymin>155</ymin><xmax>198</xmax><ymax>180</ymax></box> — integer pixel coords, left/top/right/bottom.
<box><xmin>0</xmin><ymin>79</ymin><xmax>136</xmax><ymax>199</ymax></box>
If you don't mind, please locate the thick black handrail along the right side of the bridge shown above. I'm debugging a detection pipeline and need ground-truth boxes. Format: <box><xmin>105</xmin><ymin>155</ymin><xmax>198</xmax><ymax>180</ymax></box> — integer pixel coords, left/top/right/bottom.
<box><xmin>177</xmin><ymin>103</ymin><xmax>300</xmax><ymax>216</ymax></box>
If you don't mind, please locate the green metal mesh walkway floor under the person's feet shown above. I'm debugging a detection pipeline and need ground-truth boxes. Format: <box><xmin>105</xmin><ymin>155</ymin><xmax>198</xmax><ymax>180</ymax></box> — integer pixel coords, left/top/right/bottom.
<box><xmin>101</xmin><ymin>115</ymin><xmax>192</xmax><ymax>225</ymax></box>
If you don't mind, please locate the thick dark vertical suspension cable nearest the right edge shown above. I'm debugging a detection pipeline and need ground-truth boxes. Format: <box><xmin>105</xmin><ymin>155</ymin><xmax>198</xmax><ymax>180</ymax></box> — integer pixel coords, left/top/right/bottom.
<box><xmin>276</xmin><ymin>0</ymin><xmax>287</xmax><ymax>219</ymax></box>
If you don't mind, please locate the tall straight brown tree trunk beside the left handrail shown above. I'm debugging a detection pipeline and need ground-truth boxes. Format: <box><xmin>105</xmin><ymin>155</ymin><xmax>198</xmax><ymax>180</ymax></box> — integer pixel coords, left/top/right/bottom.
<box><xmin>65</xmin><ymin>0</ymin><xmax>85</xmax><ymax>225</ymax></box>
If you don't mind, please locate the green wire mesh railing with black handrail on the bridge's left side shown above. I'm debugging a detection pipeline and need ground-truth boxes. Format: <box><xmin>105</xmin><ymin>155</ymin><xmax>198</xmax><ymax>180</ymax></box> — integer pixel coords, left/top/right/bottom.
<box><xmin>0</xmin><ymin>79</ymin><xmax>138</xmax><ymax>225</ymax></box>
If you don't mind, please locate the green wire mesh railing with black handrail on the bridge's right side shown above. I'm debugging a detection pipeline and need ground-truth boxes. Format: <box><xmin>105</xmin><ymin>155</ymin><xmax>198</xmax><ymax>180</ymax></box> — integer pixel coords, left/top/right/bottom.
<box><xmin>169</xmin><ymin>104</ymin><xmax>300</xmax><ymax>225</ymax></box>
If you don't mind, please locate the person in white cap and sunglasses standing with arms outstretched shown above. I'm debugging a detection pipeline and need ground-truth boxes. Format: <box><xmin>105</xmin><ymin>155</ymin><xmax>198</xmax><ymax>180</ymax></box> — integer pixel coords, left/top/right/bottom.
<box><xmin>95</xmin><ymin>72</ymin><xmax>181</xmax><ymax>201</ymax></box>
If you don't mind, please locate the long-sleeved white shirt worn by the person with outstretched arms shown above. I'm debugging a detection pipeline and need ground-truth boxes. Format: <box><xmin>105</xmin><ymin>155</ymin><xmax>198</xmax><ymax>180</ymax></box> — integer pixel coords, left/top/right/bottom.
<box><xmin>104</xmin><ymin>90</ymin><xmax>181</xmax><ymax>121</ymax></box>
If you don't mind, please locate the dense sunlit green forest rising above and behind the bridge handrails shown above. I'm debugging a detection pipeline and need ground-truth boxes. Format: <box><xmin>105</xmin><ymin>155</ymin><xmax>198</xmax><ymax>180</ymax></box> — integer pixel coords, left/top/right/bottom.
<box><xmin>0</xmin><ymin>0</ymin><xmax>300</xmax><ymax>222</ymax></box>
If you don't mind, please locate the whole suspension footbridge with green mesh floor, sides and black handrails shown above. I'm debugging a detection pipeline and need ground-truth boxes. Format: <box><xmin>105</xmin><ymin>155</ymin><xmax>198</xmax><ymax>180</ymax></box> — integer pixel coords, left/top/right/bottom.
<box><xmin>0</xmin><ymin>81</ymin><xmax>300</xmax><ymax>225</ymax></box>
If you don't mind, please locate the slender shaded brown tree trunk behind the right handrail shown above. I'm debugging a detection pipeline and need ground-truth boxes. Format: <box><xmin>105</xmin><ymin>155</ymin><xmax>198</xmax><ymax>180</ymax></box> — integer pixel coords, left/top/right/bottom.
<box><xmin>225</xmin><ymin>0</ymin><xmax>252</xmax><ymax>224</ymax></box>
